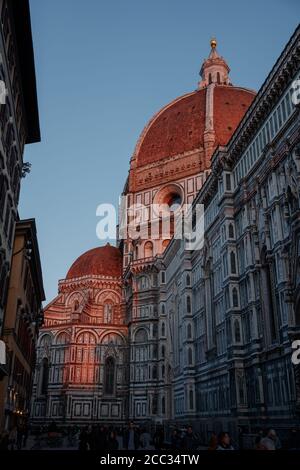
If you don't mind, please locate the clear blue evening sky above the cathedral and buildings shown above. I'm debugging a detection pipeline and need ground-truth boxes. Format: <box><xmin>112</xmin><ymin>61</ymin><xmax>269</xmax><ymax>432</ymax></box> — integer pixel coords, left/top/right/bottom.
<box><xmin>19</xmin><ymin>0</ymin><xmax>300</xmax><ymax>302</ymax></box>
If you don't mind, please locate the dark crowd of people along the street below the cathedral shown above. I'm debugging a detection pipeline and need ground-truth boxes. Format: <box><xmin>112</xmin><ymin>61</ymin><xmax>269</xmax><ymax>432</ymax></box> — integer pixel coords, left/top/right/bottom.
<box><xmin>0</xmin><ymin>422</ymin><xmax>300</xmax><ymax>453</ymax></box>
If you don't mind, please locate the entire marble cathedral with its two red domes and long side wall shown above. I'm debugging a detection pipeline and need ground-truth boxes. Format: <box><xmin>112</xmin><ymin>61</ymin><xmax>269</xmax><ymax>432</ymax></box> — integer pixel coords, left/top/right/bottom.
<box><xmin>32</xmin><ymin>30</ymin><xmax>300</xmax><ymax>435</ymax></box>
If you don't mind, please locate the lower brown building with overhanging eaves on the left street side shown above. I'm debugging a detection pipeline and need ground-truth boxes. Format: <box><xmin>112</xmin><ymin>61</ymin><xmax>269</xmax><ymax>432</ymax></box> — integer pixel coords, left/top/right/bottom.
<box><xmin>0</xmin><ymin>219</ymin><xmax>45</xmax><ymax>431</ymax></box>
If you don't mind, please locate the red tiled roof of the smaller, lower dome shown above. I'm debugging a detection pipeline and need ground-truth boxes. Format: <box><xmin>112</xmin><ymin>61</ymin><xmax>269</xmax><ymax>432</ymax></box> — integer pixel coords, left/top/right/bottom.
<box><xmin>66</xmin><ymin>243</ymin><xmax>122</xmax><ymax>279</ymax></box>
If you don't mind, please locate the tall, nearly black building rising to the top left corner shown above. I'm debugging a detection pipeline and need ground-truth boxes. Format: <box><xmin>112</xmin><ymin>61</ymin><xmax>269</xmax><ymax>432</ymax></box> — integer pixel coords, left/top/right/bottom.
<box><xmin>0</xmin><ymin>0</ymin><xmax>40</xmax><ymax>373</ymax></box>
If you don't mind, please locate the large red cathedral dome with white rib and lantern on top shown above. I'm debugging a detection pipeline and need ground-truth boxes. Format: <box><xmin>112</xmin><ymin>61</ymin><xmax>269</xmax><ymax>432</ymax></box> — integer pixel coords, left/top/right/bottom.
<box><xmin>132</xmin><ymin>38</ymin><xmax>255</xmax><ymax>168</ymax></box>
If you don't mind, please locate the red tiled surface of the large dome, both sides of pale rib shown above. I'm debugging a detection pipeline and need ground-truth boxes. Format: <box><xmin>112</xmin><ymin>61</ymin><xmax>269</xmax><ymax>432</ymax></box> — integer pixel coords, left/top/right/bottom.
<box><xmin>135</xmin><ymin>85</ymin><xmax>255</xmax><ymax>166</ymax></box>
